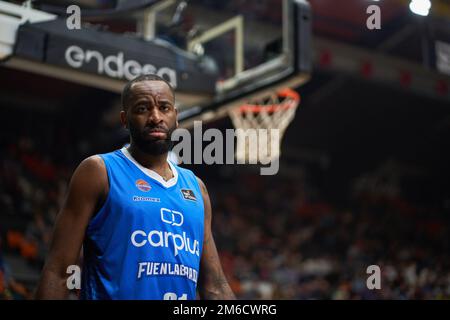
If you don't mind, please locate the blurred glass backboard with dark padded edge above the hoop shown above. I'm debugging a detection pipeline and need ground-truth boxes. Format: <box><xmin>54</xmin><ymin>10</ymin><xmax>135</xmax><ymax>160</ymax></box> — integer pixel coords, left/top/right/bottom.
<box><xmin>167</xmin><ymin>0</ymin><xmax>311</xmax><ymax>128</ymax></box>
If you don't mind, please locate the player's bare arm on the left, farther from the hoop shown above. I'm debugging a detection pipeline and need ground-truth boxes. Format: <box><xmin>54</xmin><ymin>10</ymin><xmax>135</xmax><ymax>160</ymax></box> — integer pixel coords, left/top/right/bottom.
<box><xmin>36</xmin><ymin>156</ymin><xmax>108</xmax><ymax>299</ymax></box>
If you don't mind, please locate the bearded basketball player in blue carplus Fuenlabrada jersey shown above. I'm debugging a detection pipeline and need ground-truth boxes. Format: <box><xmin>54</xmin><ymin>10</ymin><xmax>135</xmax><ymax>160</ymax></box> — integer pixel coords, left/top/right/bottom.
<box><xmin>36</xmin><ymin>75</ymin><xmax>235</xmax><ymax>300</ymax></box>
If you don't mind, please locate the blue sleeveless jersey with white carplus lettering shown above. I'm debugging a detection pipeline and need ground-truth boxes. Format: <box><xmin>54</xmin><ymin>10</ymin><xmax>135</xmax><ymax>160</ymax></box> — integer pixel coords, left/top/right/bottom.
<box><xmin>80</xmin><ymin>148</ymin><xmax>204</xmax><ymax>300</ymax></box>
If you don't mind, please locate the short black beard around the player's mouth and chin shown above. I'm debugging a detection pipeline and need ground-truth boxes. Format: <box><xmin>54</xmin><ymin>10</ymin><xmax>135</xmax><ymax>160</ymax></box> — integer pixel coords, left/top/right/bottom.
<box><xmin>128</xmin><ymin>122</ymin><xmax>176</xmax><ymax>156</ymax></box>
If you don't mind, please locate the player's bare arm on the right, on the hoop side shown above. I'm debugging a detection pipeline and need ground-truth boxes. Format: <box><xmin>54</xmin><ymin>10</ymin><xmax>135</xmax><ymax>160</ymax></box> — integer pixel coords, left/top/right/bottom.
<box><xmin>197</xmin><ymin>178</ymin><xmax>236</xmax><ymax>300</ymax></box>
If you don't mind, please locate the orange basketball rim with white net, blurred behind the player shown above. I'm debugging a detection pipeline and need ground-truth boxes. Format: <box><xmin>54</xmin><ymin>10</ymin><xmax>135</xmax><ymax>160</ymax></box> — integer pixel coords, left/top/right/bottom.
<box><xmin>229</xmin><ymin>89</ymin><xmax>300</xmax><ymax>164</ymax></box>
